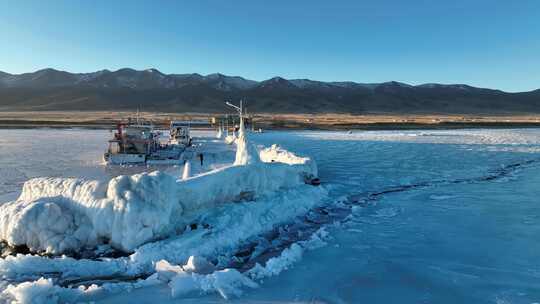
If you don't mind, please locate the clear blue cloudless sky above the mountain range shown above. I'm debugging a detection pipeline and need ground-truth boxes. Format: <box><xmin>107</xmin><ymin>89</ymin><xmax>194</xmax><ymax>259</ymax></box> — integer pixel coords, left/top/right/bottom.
<box><xmin>0</xmin><ymin>0</ymin><xmax>540</xmax><ymax>91</ymax></box>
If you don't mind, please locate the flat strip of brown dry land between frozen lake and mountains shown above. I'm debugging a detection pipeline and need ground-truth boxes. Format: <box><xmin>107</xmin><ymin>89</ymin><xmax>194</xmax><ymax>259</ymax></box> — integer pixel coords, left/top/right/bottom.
<box><xmin>0</xmin><ymin>111</ymin><xmax>540</xmax><ymax>130</ymax></box>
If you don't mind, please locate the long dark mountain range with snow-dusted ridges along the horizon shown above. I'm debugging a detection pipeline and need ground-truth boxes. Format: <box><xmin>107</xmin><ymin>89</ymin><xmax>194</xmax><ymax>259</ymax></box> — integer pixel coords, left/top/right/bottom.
<box><xmin>0</xmin><ymin>69</ymin><xmax>540</xmax><ymax>114</ymax></box>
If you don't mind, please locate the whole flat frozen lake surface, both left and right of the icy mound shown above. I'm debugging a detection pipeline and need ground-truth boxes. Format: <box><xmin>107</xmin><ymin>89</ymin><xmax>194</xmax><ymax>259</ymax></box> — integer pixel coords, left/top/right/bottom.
<box><xmin>0</xmin><ymin>129</ymin><xmax>540</xmax><ymax>303</ymax></box>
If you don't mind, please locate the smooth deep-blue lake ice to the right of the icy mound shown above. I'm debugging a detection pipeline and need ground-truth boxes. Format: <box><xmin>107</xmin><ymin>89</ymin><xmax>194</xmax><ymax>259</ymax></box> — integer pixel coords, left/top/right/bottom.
<box><xmin>242</xmin><ymin>130</ymin><xmax>540</xmax><ymax>303</ymax></box>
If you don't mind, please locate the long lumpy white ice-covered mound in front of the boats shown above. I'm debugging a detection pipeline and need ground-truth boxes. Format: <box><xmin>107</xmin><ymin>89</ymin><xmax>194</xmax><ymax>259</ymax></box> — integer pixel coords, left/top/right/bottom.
<box><xmin>0</xmin><ymin>146</ymin><xmax>317</xmax><ymax>253</ymax></box>
